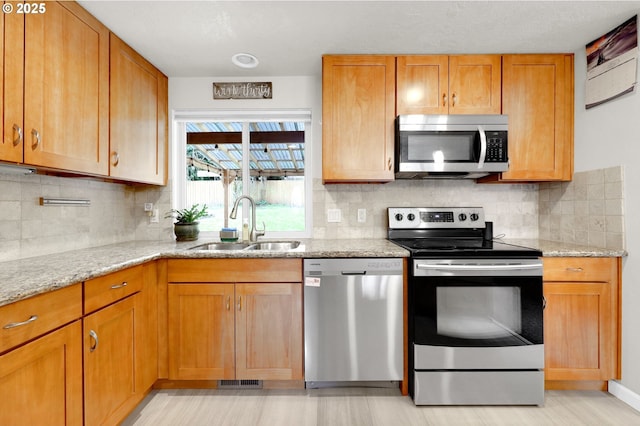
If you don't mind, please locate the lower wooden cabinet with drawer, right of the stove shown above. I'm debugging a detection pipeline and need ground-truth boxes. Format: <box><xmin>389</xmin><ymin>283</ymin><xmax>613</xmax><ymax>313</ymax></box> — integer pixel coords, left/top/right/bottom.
<box><xmin>544</xmin><ymin>257</ymin><xmax>620</xmax><ymax>389</ymax></box>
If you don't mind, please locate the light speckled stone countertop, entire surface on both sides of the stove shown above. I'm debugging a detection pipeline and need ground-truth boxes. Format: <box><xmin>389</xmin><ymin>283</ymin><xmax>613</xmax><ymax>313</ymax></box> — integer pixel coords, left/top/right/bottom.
<box><xmin>0</xmin><ymin>239</ymin><xmax>626</xmax><ymax>306</ymax></box>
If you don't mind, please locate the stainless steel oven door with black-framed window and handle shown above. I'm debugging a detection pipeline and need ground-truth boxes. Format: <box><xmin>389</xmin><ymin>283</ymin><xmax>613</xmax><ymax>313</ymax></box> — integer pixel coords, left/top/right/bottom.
<box><xmin>409</xmin><ymin>259</ymin><xmax>544</xmax><ymax>370</ymax></box>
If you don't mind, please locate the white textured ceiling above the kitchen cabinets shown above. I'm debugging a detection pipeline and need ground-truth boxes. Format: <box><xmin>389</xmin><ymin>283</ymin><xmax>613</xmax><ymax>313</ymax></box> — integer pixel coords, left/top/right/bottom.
<box><xmin>79</xmin><ymin>0</ymin><xmax>640</xmax><ymax>77</ymax></box>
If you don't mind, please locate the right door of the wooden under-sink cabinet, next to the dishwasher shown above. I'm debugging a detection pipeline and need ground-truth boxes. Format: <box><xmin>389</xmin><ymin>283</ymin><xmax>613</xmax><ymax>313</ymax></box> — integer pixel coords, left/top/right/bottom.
<box><xmin>236</xmin><ymin>283</ymin><xmax>303</xmax><ymax>380</ymax></box>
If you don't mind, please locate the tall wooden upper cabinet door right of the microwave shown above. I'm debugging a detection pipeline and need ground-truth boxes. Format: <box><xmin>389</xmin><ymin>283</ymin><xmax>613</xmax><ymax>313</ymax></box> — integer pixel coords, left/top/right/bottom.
<box><xmin>501</xmin><ymin>55</ymin><xmax>573</xmax><ymax>181</ymax></box>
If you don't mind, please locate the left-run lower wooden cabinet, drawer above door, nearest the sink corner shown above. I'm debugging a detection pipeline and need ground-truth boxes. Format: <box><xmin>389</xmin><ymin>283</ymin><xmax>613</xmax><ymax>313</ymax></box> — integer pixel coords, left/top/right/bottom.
<box><xmin>83</xmin><ymin>262</ymin><xmax>158</xmax><ymax>425</ymax></box>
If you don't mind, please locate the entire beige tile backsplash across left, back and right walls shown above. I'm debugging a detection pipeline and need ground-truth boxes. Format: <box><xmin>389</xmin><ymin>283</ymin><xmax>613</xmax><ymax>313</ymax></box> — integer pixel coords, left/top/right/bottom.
<box><xmin>0</xmin><ymin>167</ymin><xmax>625</xmax><ymax>261</ymax></box>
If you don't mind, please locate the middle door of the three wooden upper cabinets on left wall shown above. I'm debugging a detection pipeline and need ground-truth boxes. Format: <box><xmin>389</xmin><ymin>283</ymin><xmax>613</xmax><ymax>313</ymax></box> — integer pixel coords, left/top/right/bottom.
<box><xmin>24</xmin><ymin>2</ymin><xmax>109</xmax><ymax>175</ymax></box>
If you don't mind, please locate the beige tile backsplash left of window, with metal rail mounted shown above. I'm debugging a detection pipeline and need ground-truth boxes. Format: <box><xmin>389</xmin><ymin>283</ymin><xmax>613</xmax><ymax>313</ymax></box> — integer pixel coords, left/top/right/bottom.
<box><xmin>0</xmin><ymin>172</ymin><xmax>170</xmax><ymax>261</ymax></box>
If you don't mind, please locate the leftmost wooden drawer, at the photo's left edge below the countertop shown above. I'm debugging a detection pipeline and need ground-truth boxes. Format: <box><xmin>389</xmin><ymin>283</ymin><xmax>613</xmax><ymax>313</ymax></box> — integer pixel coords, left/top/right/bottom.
<box><xmin>0</xmin><ymin>284</ymin><xmax>82</xmax><ymax>353</ymax></box>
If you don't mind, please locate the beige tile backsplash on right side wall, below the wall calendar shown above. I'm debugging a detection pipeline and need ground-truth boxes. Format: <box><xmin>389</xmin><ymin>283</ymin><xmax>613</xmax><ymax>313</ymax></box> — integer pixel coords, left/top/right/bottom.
<box><xmin>538</xmin><ymin>166</ymin><xmax>626</xmax><ymax>249</ymax></box>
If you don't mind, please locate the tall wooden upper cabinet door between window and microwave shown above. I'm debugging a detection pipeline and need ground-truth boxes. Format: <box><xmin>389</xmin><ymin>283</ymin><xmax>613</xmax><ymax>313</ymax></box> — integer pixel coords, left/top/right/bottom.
<box><xmin>322</xmin><ymin>55</ymin><xmax>395</xmax><ymax>183</ymax></box>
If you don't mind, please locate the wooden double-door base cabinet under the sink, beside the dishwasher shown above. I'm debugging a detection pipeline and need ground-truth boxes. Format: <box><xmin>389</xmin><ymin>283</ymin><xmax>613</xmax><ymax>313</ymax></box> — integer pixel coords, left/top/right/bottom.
<box><xmin>168</xmin><ymin>259</ymin><xmax>303</xmax><ymax>380</ymax></box>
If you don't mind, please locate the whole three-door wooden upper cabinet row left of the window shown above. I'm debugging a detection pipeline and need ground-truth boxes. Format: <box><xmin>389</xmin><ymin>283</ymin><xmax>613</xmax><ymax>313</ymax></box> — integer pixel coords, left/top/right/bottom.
<box><xmin>0</xmin><ymin>1</ymin><xmax>168</xmax><ymax>185</ymax></box>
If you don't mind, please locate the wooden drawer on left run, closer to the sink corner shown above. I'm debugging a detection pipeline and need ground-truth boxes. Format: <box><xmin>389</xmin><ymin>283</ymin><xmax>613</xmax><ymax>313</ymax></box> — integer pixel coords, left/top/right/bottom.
<box><xmin>84</xmin><ymin>266</ymin><xmax>142</xmax><ymax>314</ymax></box>
